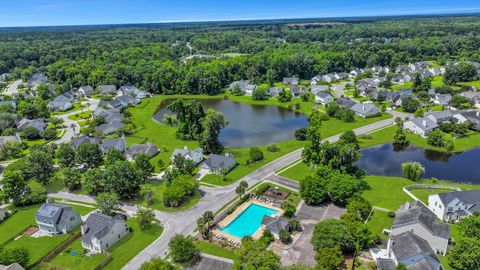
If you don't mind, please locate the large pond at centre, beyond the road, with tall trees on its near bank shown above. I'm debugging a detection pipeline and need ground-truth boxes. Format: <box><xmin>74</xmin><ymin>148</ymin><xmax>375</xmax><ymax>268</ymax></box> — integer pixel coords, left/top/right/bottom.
<box><xmin>153</xmin><ymin>99</ymin><xmax>308</xmax><ymax>148</ymax></box>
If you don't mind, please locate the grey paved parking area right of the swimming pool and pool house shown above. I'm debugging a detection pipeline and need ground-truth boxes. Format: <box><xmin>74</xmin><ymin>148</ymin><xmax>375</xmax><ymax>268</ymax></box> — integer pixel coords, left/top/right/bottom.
<box><xmin>272</xmin><ymin>203</ymin><xmax>345</xmax><ymax>266</ymax></box>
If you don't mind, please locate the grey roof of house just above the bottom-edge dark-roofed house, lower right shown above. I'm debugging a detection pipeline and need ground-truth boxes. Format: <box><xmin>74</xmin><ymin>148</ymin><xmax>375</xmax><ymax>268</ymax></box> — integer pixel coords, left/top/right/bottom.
<box><xmin>392</xmin><ymin>201</ymin><xmax>450</xmax><ymax>239</ymax></box>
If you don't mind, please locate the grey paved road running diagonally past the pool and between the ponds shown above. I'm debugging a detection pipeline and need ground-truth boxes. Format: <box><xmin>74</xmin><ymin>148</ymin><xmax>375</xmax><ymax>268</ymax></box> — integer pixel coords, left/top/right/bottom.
<box><xmin>49</xmin><ymin>112</ymin><xmax>394</xmax><ymax>270</ymax></box>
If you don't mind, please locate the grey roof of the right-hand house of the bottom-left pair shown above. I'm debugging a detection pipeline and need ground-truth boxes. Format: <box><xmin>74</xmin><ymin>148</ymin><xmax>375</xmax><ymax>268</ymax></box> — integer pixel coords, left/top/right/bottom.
<box><xmin>82</xmin><ymin>213</ymin><xmax>125</xmax><ymax>247</ymax></box>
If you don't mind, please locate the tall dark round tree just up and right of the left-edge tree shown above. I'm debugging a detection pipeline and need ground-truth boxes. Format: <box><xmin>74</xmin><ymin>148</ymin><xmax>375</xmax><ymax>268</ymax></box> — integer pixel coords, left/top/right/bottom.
<box><xmin>27</xmin><ymin>149</ymin><xmax>53</xmax><ymax>185</ymax></box>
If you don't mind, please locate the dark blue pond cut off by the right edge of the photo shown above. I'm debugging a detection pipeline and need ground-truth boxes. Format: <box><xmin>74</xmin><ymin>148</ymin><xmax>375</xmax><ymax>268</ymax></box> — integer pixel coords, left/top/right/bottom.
<box><xmin>357</xmin><ymin>143</ymin><xmax>480</xmax><ymax>184</ymax></box>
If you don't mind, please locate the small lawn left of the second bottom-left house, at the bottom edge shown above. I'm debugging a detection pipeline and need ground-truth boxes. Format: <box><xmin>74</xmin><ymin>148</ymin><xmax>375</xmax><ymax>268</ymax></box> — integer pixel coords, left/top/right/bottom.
<box><xmin>49</xmin><ymin>239</ymin><xmax>105</xmax><ymax>269</ymax></box>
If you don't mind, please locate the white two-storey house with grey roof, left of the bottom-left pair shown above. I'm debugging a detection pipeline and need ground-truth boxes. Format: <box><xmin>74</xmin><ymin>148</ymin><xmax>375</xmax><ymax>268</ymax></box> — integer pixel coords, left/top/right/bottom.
<box><xmin>35</xmin><ymin>199</ymin><xmax>82</xmax><ymax>234</ymax></box>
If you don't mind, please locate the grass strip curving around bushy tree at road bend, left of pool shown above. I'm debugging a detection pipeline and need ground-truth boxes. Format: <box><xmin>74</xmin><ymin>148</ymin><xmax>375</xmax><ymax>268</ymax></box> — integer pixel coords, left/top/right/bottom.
<box><xmin>134</xmin><ymin>181</ymin><xmax>202</xmax><ymax>212</ymax></box>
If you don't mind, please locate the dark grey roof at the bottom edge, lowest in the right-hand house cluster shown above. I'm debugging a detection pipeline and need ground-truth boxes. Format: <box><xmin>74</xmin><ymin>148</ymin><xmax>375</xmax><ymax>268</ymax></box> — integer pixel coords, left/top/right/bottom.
<box><xmin>391</xmin><ymin>231</ymin><xmax>441</xmax><ymax>270</ymax></box>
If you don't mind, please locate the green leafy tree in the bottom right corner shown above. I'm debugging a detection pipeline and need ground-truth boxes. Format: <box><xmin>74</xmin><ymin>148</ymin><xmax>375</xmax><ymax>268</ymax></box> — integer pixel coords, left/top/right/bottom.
<box><xmin>447</xmin><ymin>237</ymin><xmax>480</xmax><ymax>270</ymax></box>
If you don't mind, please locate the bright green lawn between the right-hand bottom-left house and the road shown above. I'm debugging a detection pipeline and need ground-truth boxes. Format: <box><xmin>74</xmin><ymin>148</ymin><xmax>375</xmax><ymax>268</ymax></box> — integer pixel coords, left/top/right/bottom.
<box><xmin>102</xmin><ymin>218</ymin><xmax>163</xmax><ymax>269</ymax></box>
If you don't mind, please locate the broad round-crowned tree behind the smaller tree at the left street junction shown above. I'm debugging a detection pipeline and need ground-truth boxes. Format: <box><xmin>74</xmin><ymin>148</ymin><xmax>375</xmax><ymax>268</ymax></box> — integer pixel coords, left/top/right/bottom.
<box><xmin>103</xmin><ymin>161</ymin><xmax>144</xmax><ymax>200</ymax></box>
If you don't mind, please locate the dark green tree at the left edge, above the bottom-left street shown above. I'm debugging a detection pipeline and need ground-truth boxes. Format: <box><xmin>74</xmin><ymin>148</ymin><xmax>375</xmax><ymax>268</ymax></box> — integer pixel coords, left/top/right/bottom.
<box><xmin>0</xmin><ymin>171</ymin><xmax>28</xmax><ymax>206</ymax></box>
